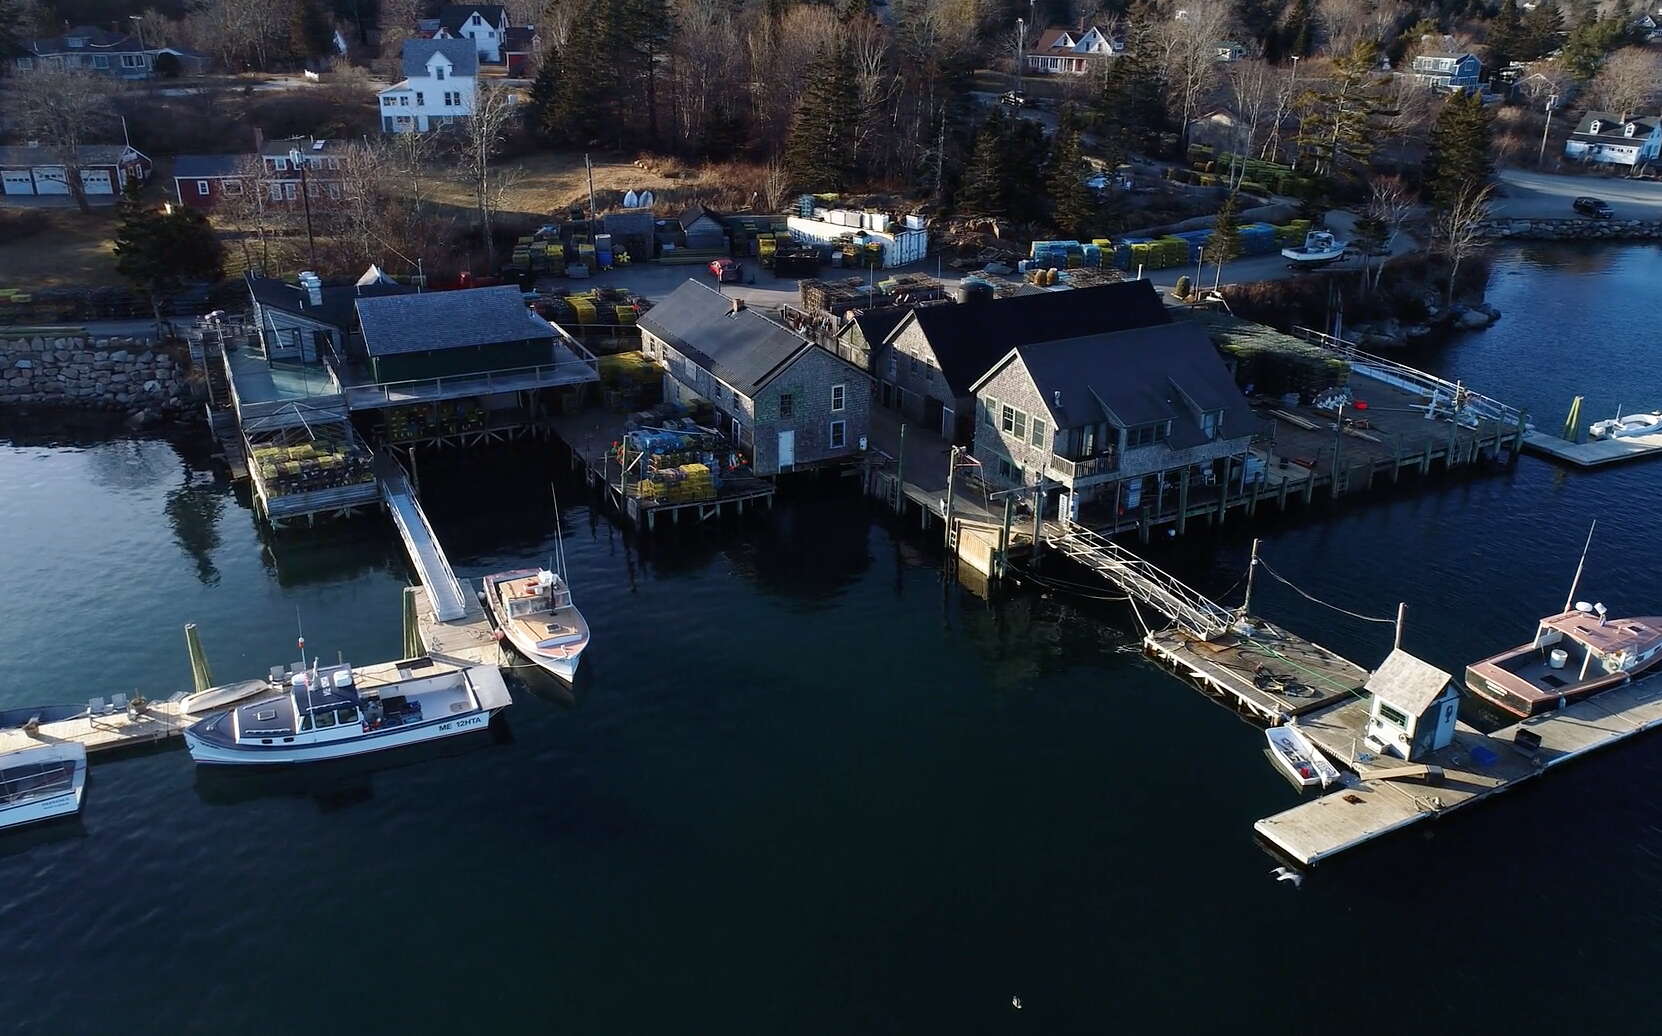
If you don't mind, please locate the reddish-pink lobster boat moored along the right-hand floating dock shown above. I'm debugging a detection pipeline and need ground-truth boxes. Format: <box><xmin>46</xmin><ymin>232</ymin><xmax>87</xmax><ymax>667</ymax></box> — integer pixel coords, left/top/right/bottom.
<box><xmin>1466</xmin><ymin>602</ymin><xmax>1662</xmax><ymax>712</ymax></box>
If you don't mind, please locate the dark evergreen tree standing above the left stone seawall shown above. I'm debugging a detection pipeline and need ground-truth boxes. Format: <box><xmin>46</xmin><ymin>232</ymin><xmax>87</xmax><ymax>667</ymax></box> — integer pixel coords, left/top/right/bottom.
<box><xmin>113</xmin><ymin>180</ymin><xmax>224</xmax><ymax>329</ymax></box>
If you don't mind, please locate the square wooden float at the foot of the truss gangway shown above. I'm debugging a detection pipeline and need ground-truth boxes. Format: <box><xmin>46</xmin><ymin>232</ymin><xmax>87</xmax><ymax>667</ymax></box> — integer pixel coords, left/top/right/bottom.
<box><xmin>1143</xmin><ymin>622</ymin><xmax>1368</xmax><ymax>725</ymax></box>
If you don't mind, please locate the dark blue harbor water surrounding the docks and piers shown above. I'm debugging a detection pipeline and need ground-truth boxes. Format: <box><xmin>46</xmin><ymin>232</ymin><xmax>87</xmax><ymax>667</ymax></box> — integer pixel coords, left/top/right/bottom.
<box><xmin>0</xmin><ymin>249</ymin><xmax>1662</xmax><ymax>1033</ymax></box>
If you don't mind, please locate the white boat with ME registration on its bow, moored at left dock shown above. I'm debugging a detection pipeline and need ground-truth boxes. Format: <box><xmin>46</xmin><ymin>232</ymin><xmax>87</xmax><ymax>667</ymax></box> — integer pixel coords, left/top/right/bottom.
<box><xmin>184</xmin><ymin>659</ymin><xmax>512</xmax><ymax>765</ymax></box>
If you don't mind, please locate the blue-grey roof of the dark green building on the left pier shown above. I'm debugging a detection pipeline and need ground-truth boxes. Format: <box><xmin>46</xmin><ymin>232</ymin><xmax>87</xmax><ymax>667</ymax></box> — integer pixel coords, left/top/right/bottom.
<box><xmin>357</xmin><ymin>284</ymin><xmax>555</xmax><ymax>356</ymax></box>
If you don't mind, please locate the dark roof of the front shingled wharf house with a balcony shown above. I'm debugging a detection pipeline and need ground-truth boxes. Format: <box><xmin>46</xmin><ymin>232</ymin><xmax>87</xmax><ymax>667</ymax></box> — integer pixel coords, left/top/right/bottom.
<box><xmin>977</xmin><ymin>321</ymin><xmax>1258</xmax><ymax>449</ymax></box>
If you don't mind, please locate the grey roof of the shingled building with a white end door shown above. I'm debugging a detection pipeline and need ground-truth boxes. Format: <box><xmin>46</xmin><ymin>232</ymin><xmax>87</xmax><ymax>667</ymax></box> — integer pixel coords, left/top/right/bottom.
<box><xmin>640</xmin><ymin>279</ymin><xmax>827</xmax><ymax>396</ymax></box>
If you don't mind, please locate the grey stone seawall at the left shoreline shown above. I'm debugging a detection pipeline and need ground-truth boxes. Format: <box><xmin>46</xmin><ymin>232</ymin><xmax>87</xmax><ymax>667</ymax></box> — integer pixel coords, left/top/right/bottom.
<box><xmin>0</xmin><ymin>336</ymin><xmax>189</xmax><ymax>421</ymax></box>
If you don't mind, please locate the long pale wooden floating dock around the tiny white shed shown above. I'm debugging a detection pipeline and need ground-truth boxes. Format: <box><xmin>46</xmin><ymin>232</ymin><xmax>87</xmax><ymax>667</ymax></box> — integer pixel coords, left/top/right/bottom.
<box><xmin>1253</xmin><ymin>680</ymin><xmax>1662</xmax><ymax>866</ymax></box>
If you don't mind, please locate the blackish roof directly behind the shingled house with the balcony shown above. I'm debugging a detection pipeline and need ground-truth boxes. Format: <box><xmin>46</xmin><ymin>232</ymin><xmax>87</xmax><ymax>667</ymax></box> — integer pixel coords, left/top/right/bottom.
<box><xmin>906</xmin><ymin>281</ymin><xmax>1172</xmax><ymax>396</ymax></box>
